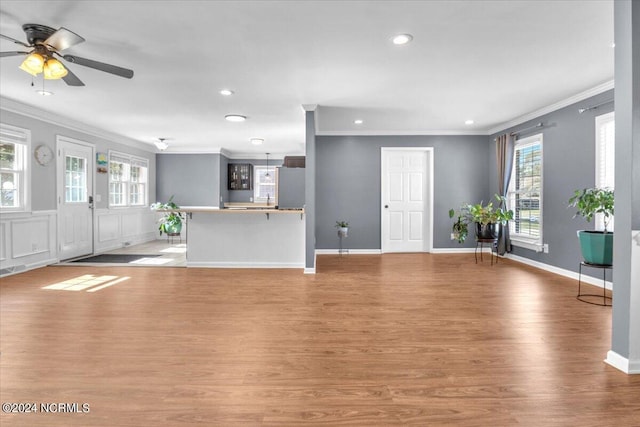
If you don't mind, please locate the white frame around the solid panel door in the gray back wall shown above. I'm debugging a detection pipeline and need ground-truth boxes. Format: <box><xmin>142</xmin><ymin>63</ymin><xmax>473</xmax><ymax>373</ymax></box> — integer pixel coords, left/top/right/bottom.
<box><xmin>380</xmin><ymin>147</ymin><xmax>434</xmax><ymax>253</ymax></box>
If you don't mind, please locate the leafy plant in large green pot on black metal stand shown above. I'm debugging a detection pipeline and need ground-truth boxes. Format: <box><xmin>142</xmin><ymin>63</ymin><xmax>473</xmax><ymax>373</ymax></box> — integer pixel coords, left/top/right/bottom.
<box><xmin>569</xmin><ymin>188</ymin><xmax>614</xmax><ymax>265</ymax></box>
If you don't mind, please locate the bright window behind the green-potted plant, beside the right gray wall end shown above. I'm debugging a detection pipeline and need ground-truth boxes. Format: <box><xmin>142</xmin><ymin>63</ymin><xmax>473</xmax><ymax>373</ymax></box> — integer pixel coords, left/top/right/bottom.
<box><xmin>594</xmin><ymin>112</ymin><xmax>616</xmax><ymax>231</ymax></box>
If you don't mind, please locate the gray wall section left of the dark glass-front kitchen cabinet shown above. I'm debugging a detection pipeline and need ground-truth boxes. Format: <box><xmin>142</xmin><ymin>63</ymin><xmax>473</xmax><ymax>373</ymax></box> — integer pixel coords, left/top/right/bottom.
<box><xmin>156</xmin><ymin>153</ymin><xmax>221</xmax><ymax>206</ymax></box>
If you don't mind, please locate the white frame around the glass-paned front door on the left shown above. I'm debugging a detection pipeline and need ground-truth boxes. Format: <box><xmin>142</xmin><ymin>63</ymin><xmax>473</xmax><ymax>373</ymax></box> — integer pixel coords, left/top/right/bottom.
<box><xmin>56</xmin><ymin>135</ymin><xmax>96</xmax><ymax>257</ymax></box>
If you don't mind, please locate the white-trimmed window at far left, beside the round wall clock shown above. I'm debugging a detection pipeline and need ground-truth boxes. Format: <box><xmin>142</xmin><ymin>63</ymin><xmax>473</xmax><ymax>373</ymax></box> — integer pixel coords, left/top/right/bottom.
<box><xmin>0</xmin><ymin>123</ymin><xmax>31</xmax><ymax>212</ymax></box>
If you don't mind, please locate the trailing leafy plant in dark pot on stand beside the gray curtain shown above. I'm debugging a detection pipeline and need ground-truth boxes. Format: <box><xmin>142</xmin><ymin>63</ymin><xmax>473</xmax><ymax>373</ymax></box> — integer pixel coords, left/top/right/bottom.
<box><xmin>449</xmin><ymin>194</ymin><xmax>513</xmax><ymax>243</ymax></box>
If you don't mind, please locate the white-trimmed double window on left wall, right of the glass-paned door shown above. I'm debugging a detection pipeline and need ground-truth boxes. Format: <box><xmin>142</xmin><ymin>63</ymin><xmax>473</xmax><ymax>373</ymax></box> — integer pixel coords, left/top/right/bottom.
<box><xmin>109</xmin><ymin>151</ymin><xmax>149</xmax><ymax>207</ymax></box>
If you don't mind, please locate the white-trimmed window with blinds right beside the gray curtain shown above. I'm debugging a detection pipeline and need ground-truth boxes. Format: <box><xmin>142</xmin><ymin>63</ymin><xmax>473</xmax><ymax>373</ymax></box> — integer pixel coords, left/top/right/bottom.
<box><xmin>508</xmin><ymin>134</ymin><xmax>542</xmax><ymax>250</ymax></box>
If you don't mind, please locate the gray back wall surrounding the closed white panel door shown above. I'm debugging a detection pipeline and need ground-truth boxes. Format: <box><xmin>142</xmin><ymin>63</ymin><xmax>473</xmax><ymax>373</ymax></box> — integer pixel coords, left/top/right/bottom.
<box><xmin>315</xmin><ymin>136</ymin><xmax>495</xmax><ymax>249</ymax></box>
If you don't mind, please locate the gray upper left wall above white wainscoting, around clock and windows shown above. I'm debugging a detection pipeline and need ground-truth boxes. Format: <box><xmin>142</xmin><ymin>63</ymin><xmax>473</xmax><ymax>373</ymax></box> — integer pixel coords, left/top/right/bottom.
<box><xmin>0</xmin><ymin>110</ymin><xmax>156</xmax><ymax>211</ymax></box>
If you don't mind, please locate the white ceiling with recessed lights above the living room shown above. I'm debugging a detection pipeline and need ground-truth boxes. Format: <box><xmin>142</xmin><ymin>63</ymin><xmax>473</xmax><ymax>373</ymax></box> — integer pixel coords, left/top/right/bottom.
<box><xmin>0</xmin><ymin>0</ymin><xmax>614</xmax><ymax>155</ymax></box>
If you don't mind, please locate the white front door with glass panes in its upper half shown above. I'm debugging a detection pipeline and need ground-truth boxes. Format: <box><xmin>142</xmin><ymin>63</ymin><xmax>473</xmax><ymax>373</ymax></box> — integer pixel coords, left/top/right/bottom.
<box><xmin>57</xmin><ymin>137</ymin><xmax>95</xmax><ymax>260</ymax></box>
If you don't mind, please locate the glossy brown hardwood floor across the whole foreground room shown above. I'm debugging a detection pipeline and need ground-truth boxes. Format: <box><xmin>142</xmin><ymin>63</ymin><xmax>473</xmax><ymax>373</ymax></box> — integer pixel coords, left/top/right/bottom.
<box><xmin>0</xmin><ymin>254</ymin><xmax>640</xmax><ymax>427</ymax></box>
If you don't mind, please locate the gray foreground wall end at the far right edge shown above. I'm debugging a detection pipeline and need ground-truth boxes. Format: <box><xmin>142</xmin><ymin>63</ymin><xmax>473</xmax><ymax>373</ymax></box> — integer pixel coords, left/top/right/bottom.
<box><xmin>611</xmin><ymin>1</ymin><xmax>640</xmax><ymax>371</ymax></box>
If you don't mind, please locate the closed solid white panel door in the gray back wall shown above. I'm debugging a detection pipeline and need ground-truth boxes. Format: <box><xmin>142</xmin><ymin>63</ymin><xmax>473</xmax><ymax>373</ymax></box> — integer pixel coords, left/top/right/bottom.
<box><xmin>381</xmin><ymin>147</ymin><xmax>433</xmax><ymax>252</ymax></box>
